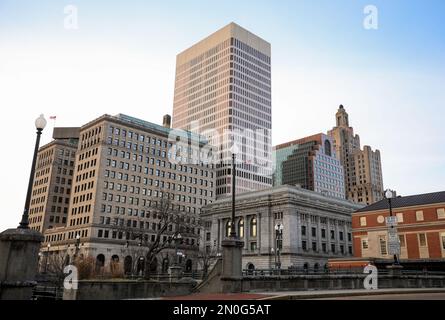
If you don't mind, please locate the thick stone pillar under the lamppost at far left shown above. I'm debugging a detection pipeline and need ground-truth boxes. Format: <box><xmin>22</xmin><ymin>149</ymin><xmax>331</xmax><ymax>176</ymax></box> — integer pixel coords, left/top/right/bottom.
<box><xmin>0</xmin><ymin>229</ymin><xmax>43</xmax><ymax>300</ymax></box>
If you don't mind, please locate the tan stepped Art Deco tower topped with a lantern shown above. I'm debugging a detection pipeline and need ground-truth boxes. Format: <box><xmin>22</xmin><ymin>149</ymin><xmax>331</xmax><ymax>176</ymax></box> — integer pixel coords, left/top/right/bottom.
<box><xmin>328</xmin><ymin>105</ymin><xmax>383</xmax><ymax>205</ymax></box>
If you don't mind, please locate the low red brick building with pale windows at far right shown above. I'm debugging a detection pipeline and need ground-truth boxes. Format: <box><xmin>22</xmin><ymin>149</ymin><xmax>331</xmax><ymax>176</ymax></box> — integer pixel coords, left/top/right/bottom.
<box><xmin>352</xmin><ymin>192</ymin><xmax>445</xmax><ymax>261</ymax></box>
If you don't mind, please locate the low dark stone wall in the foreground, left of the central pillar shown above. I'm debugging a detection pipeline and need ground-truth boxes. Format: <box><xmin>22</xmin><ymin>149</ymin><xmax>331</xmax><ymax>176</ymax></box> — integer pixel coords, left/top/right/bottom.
<box><xmin>63</xmin><ymin>280</ymin><xmax>196</xmax><ymax>300</ymax></box>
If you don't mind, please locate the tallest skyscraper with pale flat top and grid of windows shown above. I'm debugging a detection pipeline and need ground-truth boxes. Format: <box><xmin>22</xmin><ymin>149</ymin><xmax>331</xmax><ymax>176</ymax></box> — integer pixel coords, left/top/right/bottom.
<box><xmin>173</xmin><ymin>23</ymin><xmax>272</xmax><ymax>196</ymax></box>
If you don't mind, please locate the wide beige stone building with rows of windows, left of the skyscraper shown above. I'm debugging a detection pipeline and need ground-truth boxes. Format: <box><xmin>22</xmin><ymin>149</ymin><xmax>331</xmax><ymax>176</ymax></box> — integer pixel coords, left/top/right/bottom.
<box><xmin>42</xmin><ymin>114</ymin><xmax>216</xmax><ymax>272</ymax></box>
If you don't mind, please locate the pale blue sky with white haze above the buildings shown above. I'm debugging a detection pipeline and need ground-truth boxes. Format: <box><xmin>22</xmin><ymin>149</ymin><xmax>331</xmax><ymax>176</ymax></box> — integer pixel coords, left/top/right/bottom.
<box><xmin>0</xmin><ymin>0</ymin><xmax>445</xmax><ymax>231</ymax></box>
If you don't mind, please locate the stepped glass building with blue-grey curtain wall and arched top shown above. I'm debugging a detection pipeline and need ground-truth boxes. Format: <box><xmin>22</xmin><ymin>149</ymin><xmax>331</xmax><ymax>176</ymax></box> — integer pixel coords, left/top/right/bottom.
<box><xmin>274</xmin><ymin>133</ymin><xmax>345</xmax><ymax>199</ymax></box>
